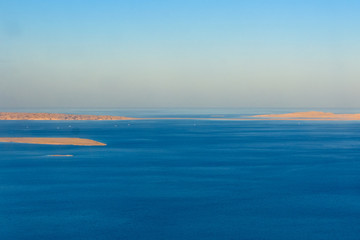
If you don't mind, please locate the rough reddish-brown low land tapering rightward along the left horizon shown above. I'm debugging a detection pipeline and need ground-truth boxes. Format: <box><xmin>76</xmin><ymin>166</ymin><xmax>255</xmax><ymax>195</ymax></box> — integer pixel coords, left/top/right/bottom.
<box><xmin>0</xmin><ymin>112</ymin><xmax>136</xmax><ymax>121</ymax></box>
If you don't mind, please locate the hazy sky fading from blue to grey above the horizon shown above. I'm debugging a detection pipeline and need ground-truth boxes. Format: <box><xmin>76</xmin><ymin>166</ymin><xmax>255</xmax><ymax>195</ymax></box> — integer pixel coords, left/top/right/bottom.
<box><xmin>0</xmin><ymin>0</ymin><xmax>360</xmax><ymax>108</ymax></box>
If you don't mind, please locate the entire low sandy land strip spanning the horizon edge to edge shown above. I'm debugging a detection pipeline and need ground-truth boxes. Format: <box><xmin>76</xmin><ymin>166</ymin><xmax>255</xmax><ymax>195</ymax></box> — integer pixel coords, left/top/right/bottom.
<box><xmin>0</xmin><ymin>111</ymin><xmax>360</xmax><ymax>121</ymax></box>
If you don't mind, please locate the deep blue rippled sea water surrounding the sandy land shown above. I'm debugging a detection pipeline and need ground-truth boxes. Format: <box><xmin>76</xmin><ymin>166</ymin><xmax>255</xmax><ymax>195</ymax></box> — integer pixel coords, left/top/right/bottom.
<box><xmin>0</xmin><ymin>110</ymin><xmax>360</xmax><ymax>240</ymax></box>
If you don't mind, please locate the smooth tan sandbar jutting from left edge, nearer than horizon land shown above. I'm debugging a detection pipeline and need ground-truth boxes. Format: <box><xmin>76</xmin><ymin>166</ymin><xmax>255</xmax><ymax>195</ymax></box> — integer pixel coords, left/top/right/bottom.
<box><xmin>0</xmin><ymin>137</ymin><xmax>106</xmax><ymax>146</ymax></box>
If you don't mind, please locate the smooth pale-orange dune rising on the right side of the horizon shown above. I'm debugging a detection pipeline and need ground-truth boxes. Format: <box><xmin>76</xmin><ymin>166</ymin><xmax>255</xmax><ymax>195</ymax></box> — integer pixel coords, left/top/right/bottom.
<box><xmin>252</xmin><ymin>111</ymin><xmax>360</xmax><ymax>121</ymax></box>
